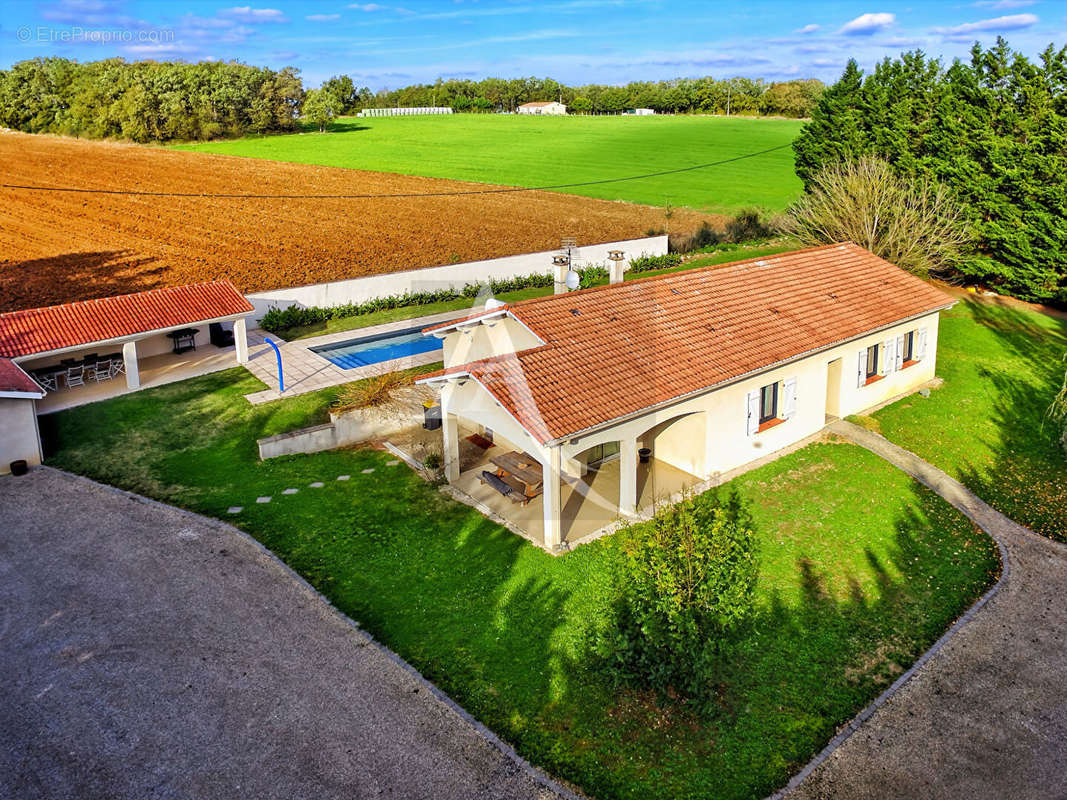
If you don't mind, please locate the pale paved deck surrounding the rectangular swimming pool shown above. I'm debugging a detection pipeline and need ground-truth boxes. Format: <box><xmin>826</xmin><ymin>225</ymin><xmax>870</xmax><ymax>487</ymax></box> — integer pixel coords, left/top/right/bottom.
<box><xmin>244</xmin><ymin>308</ymin><xmax>471</xmax><ymax>405</ymax></box>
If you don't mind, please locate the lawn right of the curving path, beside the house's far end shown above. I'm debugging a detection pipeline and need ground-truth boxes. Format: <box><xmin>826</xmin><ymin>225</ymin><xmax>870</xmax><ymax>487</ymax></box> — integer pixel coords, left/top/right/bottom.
<box><xmin>874</xmin><ymin>300</ymin><xmax>1067</xmax><ymax>541</ymax></box>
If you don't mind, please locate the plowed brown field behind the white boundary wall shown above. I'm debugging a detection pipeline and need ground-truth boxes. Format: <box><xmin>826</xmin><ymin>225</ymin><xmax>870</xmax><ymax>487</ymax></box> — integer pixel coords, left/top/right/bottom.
<box><xmin>0</xmin><ymin>131</ymin><xmax>708</xmax><ymax>310</ymax></box>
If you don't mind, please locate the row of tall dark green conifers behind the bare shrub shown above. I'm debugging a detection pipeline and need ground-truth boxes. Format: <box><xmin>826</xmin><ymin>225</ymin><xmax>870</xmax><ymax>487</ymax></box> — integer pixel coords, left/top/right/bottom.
<box><xmin>794</xmin><ymin>39</ymin><xmax>1067</xmax><ymax>304</ymax></box>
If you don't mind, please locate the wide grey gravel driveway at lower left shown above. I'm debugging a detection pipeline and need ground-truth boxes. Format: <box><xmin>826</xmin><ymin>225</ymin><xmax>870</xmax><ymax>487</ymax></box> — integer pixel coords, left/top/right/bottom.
<box><xmin>0</xmin><ymin>469</ymin><xmax>558</xmax><ymax>799</ymax></box>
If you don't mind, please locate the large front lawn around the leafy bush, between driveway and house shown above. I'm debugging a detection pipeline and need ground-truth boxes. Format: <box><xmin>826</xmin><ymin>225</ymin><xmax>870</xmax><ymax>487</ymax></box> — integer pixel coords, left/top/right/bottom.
<box><xmin>46</xmin><ymin>369</ymin><xmax>999</xmax><ymax>798</ymax></box>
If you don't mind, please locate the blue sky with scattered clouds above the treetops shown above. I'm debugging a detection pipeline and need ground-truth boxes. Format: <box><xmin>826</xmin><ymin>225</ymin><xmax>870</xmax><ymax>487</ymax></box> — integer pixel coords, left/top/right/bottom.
<box><xmin>0</xmin><ymin>0</ymin><xmax>1067</xmax><ymax>90</ymax></box>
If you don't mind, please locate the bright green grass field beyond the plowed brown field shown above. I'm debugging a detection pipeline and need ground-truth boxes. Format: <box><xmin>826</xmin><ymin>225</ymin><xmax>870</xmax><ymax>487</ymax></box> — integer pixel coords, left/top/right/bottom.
<box><xmin>180</xmin><ymin>114</ymin><xmax>802</xmax><ymax>212</ymax></box>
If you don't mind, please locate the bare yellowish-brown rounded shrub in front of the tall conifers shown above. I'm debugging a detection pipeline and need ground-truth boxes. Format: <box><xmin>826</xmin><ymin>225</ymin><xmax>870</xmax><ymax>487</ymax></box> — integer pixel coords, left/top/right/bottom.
<box><xmin>783</xmin><ymin>156</ymin><xmax>972</xmax><ymax>277</ymax></box>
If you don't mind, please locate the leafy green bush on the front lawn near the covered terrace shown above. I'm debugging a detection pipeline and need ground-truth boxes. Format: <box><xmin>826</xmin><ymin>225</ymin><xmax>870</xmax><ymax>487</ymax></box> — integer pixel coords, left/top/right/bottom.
<box><xmin>595</xmin><ymin>495</ymin><xmax>759</xmax><ymax>703</ymax></box>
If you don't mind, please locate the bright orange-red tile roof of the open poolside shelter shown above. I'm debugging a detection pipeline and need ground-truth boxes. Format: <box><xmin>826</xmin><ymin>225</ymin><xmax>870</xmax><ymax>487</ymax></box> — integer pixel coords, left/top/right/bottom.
<box><xmin>0</xmin><ymin>281</ymin><xmax>253</xmax><ymax>358</ymax></box>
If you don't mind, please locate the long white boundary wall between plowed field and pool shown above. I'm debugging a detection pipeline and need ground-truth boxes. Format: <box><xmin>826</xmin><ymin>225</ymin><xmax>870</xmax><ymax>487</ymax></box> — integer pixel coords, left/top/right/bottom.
<box><xmin>248</xmin><ymin>236</ymin><xmax>667</xmax><ymax>323</ymax></box>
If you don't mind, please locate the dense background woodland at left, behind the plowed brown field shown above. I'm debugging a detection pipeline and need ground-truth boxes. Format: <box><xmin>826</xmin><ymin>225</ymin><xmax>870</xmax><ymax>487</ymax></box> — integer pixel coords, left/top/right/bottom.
<box><xmin>0</xmin><ymin>58</ymin><xmax>304</xmax><ymax>142</ymax></box>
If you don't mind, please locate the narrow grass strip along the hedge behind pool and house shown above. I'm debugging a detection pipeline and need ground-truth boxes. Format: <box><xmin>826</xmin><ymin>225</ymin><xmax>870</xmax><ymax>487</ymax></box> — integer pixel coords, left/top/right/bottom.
<box><xmin>278</xmin><ymin>244</ymin><xmax>799</xmax><ymax>341</ymax></box>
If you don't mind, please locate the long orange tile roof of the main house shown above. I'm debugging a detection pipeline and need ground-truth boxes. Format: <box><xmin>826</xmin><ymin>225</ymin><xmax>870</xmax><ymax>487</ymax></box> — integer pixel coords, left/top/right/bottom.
<box><xmin>428</xmin><ymin>243</ymin><xmax>954</xmax><ymax>443</ymax></box>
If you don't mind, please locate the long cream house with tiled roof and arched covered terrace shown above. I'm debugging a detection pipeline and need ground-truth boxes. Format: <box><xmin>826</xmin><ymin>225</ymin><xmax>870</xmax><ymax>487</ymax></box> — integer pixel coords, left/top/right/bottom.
<box><xmin>420</xmin><ymin>243</ymin><xmax>954</xmax><ymax>550</ymax></box>
